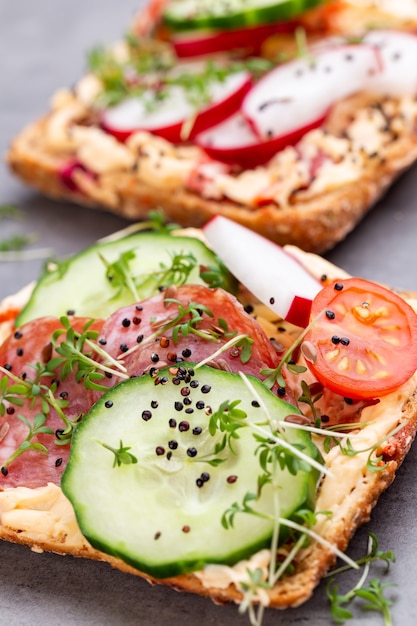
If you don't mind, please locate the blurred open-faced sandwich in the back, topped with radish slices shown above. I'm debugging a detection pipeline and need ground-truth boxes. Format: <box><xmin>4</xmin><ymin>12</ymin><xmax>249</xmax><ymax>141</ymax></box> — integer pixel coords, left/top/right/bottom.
<box><xmin>8</xmin><ymin>0</ymin><xmax>417</xmax><ymax>252</ymax></box>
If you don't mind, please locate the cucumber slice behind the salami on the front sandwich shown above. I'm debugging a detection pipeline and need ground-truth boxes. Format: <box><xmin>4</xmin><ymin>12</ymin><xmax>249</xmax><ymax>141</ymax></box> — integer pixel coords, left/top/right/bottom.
<box><xmin>16</xmin><ymin>232</ymin><xmax>234</xmax><ymax>326</ymax></box>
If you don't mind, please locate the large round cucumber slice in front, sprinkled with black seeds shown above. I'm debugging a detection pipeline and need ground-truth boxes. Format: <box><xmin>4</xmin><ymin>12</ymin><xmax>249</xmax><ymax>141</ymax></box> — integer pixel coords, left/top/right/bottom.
<box><xmin>62</xmin><ymin>364</ymin><xmax>319</xmax><ymax>578</ymax></box>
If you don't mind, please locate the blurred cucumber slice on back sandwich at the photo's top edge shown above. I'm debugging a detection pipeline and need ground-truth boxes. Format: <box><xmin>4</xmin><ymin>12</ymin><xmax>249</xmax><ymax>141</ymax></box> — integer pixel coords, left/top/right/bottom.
<box><xmin>164</xmin><ymin>0</ymin><xmax>325</xmax><ymax>30</ymax></box>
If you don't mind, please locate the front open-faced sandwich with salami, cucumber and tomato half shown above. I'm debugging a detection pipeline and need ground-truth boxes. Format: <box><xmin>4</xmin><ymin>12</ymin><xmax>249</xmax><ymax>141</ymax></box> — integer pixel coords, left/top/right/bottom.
<box><xmin>0</xmin><ymin>217</ymin><xmax>417</xmax><ymax>624</ymax></box>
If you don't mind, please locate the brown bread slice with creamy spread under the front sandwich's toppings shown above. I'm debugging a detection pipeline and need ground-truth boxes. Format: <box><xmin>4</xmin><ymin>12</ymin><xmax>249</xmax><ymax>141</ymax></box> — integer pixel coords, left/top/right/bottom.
<box><xmin>0</xmin><ymin>250</ymin><xmax>417</xmax><ymax>608</ymax></box>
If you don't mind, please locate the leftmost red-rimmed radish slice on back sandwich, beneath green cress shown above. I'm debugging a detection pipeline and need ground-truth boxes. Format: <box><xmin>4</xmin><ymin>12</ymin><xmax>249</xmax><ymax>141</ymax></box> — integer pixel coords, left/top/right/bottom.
<box><xmin>101</xmin><ymin>64</ymin><xmax>252</xmax><ymax>143</ymax></box>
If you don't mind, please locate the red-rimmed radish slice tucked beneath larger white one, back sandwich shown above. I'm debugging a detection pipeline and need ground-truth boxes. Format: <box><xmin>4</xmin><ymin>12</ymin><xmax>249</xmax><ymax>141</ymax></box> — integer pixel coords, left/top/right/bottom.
<box><xmin>194</xmin><ymin>112</ymin><xmax>324</xmax><ymax>168</ymax></box>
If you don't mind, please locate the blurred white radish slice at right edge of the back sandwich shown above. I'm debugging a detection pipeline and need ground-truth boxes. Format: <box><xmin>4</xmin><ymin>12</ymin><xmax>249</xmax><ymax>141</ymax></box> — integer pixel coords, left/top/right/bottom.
<box><xmin>364</xmin><ymin>31</ymin><xmax>417</xmax><ymax>96</ymax></box>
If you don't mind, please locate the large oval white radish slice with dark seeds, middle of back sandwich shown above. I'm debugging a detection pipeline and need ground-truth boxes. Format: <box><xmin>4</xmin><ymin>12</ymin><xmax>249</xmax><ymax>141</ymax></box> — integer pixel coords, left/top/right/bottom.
<box><xmin>242</xmin><ymin>44</ymin><xmax>380</xmax><ymax>140</ymax></box>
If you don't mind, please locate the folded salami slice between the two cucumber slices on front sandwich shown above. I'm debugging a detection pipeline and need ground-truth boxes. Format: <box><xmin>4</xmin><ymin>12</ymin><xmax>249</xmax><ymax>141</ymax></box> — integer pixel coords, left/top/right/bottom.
<box><xmin>99</xmin><ymin>285</ymin><xmax>279</xmax><ymax>377</ymax></box>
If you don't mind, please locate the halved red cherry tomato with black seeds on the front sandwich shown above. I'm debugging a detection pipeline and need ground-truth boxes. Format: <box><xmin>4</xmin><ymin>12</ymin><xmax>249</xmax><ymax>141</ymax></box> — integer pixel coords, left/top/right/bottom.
<box><xmin>305</xmin><ymin>278</ymin><xmax>417</xmax><ymax>398</ymax></box>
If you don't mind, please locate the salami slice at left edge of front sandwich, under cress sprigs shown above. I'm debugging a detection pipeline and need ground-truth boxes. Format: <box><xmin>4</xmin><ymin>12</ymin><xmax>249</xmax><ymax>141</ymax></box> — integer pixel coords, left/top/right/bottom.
<box><xmin>0</xmin><ymin>317</ymin><xmax>102</xmax><ymax>489</ymax></box>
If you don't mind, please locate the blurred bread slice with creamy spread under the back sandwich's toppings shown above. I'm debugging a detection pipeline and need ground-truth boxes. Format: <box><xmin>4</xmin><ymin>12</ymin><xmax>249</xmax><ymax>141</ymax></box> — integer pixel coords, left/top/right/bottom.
<box><xmin>7</xmin><ymin>1</ymin><xmax>417</xmax><ymax>253</ymax></box>
